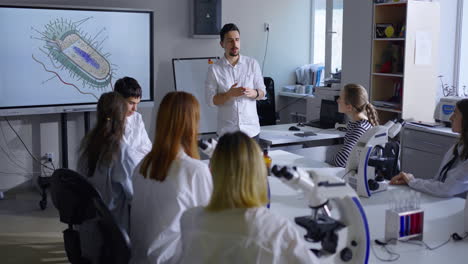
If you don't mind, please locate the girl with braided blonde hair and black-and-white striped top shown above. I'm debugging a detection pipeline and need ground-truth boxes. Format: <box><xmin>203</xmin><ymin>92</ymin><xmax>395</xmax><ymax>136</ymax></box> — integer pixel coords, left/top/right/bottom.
<box><xmin>333</xmin><ymin>83</ymin><xmax>379</xmax><ymax>167</ymax></box>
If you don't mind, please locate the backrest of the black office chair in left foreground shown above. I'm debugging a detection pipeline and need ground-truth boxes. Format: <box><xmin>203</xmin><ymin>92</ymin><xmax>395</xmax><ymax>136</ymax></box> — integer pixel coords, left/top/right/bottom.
<box><xmin>50</xmin><ymin>169</ymin><xmax>101</xmax><ymax>225</ymax></box>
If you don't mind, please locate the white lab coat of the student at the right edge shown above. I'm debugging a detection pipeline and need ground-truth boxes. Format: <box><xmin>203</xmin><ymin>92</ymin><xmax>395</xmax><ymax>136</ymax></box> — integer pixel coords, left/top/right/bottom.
<box><xmin>408</xmin><ymin>143</ymin><xmax>468</xmax><ymax>197</ymax></box>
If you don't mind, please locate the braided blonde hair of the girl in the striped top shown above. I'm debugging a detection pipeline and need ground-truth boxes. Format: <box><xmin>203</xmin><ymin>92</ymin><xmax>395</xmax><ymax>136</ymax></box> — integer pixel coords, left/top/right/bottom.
<box><xmin>343</xmin><ymin>83</ymin><xmax>379</xmax><ymax>126</ymax></box>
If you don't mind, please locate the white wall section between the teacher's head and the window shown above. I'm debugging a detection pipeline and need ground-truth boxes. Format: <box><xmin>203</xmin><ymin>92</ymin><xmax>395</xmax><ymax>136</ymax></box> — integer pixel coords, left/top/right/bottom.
<box><xmin>223</xmin><ymin>0</ymin><xmax>311</xmax><ymax>88</ymax></box>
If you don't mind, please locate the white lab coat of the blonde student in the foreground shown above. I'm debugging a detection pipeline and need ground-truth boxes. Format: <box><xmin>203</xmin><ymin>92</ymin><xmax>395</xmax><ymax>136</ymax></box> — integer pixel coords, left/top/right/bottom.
<box><xmin>180</xmin><ymin>207</ymin><xmax>318</xmax><ymax>264</ymax></box>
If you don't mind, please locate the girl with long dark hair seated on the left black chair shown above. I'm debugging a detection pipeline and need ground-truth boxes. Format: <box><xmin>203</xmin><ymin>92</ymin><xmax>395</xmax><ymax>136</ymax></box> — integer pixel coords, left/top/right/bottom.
<box><xmin>78</xmin><ymin>92</ymin><xmax>137</xmax><ymax>263</ymax></box>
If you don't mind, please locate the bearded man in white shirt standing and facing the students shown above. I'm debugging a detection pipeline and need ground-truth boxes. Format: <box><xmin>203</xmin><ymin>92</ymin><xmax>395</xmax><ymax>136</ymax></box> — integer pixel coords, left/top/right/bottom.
<box><xmin>205</xmin><ymin>24</ymin><xmax>266</xmax><ymax>141</ymax></box>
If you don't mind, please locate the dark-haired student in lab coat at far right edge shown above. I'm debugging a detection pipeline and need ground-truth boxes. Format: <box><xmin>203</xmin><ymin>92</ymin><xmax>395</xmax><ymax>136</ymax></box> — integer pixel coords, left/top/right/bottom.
<box><xmin>390</xmin><ymin>99</ymin><xmax>468</xmax><ymax>197</ymax></box>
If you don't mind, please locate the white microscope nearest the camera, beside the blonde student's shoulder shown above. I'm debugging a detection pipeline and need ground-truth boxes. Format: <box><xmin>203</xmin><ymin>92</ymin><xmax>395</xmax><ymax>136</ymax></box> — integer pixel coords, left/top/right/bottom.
<box><xmin>272</xmin><ymin>165</ymin><xmax>370</xmax><ymax>263</ymax></box>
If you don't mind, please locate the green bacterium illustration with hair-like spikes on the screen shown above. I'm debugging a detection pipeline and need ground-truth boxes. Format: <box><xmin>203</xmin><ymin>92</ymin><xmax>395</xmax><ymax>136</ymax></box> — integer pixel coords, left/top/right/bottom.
<box><xmin>33</xmin><ymin>17</ymin><xmax>113</xmax><ymax>98</ymax></box>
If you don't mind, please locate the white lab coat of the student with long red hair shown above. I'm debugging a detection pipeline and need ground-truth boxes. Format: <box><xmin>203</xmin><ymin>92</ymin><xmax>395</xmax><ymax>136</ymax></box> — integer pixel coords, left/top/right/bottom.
<box><xmin>130</xmin><ymin>151</ymin><xmax>213</xmax><ymax>263</ymax></box>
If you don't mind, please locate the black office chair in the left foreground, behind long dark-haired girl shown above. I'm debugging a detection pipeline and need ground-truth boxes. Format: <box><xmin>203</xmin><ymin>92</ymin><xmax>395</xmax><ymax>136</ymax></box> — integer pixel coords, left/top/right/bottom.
<box><xmin>50</xmin><ymin>169</ymin><xmax>131</xmax><ymax>264</ymax></box>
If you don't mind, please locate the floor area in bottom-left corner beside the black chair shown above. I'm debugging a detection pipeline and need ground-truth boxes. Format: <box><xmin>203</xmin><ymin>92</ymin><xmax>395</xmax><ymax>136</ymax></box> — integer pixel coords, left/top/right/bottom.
<box><xmin>0</xmin><ymin>182</ymin><xmax>68</xmax><ymax>264</ymax></box>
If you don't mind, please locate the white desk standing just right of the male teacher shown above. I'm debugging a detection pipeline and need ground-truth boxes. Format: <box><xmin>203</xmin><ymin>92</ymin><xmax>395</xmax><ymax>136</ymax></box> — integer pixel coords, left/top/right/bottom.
<box><xmin>260</xmin><ymin>123</ymin><xmax>345</xmax><ymax>147</ymax></box>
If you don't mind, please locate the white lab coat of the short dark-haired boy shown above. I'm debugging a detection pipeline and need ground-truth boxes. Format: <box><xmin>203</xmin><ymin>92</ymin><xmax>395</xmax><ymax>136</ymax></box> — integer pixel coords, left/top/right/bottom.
<box><xmin>123</xmin><ymin>112</ymin><xmax>153</xmax><ymax>163</ymax></box>
